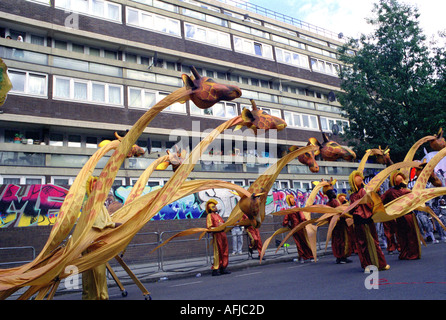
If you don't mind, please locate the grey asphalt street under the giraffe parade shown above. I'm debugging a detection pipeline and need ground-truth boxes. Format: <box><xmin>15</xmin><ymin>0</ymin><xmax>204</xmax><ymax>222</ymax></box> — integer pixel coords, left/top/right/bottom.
<box><xmin>55</xmin><ymin>242</ymin><xmax>446</xmax><ymax>302</ymax></box>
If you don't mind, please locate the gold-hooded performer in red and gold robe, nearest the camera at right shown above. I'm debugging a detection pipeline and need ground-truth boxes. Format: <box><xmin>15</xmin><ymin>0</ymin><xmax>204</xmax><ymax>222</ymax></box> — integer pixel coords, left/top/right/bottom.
<box><xmin>349</xmin><ymin>170</ymin><xmax>390</xmax><ymax>270</ymax></box>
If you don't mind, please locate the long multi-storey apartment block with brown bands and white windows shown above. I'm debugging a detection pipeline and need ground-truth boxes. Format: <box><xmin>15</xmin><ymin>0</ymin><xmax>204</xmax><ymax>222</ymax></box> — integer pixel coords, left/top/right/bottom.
<box><xmin>0</xmin><ymin>0</ymin><xmax>382</xmax><ymax>190</ymax></box>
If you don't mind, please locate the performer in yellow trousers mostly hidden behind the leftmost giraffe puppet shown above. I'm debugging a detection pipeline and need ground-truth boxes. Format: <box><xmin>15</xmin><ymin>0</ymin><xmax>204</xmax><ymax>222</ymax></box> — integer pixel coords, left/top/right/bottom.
<box><xmin>82</xmin><ymin>177</ymin><xmax>121</xmax><ymax>300</ymax></box>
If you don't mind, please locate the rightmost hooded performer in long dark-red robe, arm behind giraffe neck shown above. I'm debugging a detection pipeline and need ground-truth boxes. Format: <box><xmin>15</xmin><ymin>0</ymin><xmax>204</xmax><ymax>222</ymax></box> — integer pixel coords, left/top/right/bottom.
<box><xmin>381</xmin><ymin>171</ymin><xmax>421</xmax><ymax>260</ymax></box>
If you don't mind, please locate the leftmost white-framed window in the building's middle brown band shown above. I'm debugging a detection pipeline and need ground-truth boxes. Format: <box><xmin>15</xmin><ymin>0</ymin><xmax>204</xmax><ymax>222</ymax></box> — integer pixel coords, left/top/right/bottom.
<box><xmin>8</xmin><ymin>69</ymin><xmax>48</xmax><ymax>97</ymax></box>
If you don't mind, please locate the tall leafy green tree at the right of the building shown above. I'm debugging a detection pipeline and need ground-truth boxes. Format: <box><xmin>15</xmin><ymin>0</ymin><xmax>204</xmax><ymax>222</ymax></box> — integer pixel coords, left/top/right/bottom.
<box><xmin>339</xmin><ymin>0</ymin><xmax>444</xmax><ymax>162</ymax></box>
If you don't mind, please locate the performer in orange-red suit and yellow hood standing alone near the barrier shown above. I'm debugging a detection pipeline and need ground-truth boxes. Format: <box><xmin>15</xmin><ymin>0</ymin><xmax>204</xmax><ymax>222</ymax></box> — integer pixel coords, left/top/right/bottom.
<box><xmin>206</xmin><ymin>199</ymin><xmax>231</xmax><ymax>276</ymax></box>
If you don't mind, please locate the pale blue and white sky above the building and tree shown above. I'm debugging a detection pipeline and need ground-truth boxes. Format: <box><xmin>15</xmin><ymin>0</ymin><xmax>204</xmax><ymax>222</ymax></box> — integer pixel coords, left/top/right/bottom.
<box><xmin>247</xmin><ymin>0</ymin><xmax>446</xmax><ymax>39</ymax></box>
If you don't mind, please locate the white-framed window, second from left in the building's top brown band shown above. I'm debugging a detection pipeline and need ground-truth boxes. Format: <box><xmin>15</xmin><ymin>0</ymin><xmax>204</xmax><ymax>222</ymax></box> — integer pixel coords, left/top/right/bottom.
<box><xmin>126</xmin><ymin>7</ymin><xmax>181</xmax><ymax>37</ymax></box>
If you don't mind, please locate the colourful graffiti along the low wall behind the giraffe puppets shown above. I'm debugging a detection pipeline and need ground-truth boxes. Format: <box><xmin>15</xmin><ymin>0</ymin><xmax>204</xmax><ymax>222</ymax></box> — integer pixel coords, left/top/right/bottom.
<box><xmin>0</xmin><ymin>184</ymin><xmax>345</xmax><ymax>228</ymax></box>
